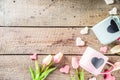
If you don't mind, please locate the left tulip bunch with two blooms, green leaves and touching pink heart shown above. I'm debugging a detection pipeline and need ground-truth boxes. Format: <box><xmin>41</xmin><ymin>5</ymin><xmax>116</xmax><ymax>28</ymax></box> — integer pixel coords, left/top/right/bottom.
<box><xmin>29</xmin><ymin>52</ymin><xmax>63</xmax><ymax>80</ymax></box>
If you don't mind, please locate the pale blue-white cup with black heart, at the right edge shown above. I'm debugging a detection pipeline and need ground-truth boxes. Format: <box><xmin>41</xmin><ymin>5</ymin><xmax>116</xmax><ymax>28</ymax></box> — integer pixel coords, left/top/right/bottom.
<box><xmin>92</xmin><ymin>16</ymin><xmax>120</xmax><ymax>44</ymax></box>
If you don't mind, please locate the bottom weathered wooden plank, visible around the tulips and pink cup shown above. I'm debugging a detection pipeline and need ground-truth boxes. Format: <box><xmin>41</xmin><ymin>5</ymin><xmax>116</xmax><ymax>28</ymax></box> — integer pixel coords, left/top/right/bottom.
<box><xmin>0</xmin><ymin>55</ymin><xmax>120</xmax><ymax>80</ymax></box>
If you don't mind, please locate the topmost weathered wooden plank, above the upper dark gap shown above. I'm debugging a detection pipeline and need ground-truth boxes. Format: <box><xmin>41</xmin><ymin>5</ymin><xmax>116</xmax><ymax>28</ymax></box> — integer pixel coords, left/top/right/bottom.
<box><xmin>0</xmin><ymin>0</ymin><xmax>120</xmax><ymax>27</ymax></box>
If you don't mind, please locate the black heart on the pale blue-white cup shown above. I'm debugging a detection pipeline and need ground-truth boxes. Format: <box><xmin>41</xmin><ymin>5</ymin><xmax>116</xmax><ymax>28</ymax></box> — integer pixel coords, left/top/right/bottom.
<box><xmin>107</xmin><ymin>19</ymin><xmax>119</xmax><ymax>33</ymax></box>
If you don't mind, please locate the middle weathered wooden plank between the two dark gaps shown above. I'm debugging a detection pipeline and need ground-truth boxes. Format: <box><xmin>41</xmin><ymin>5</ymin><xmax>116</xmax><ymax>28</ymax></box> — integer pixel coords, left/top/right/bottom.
<box><xmin>0</xmin><ymin>27</ymin><xmax>109</xmax><ymax>54</ymax></box>
